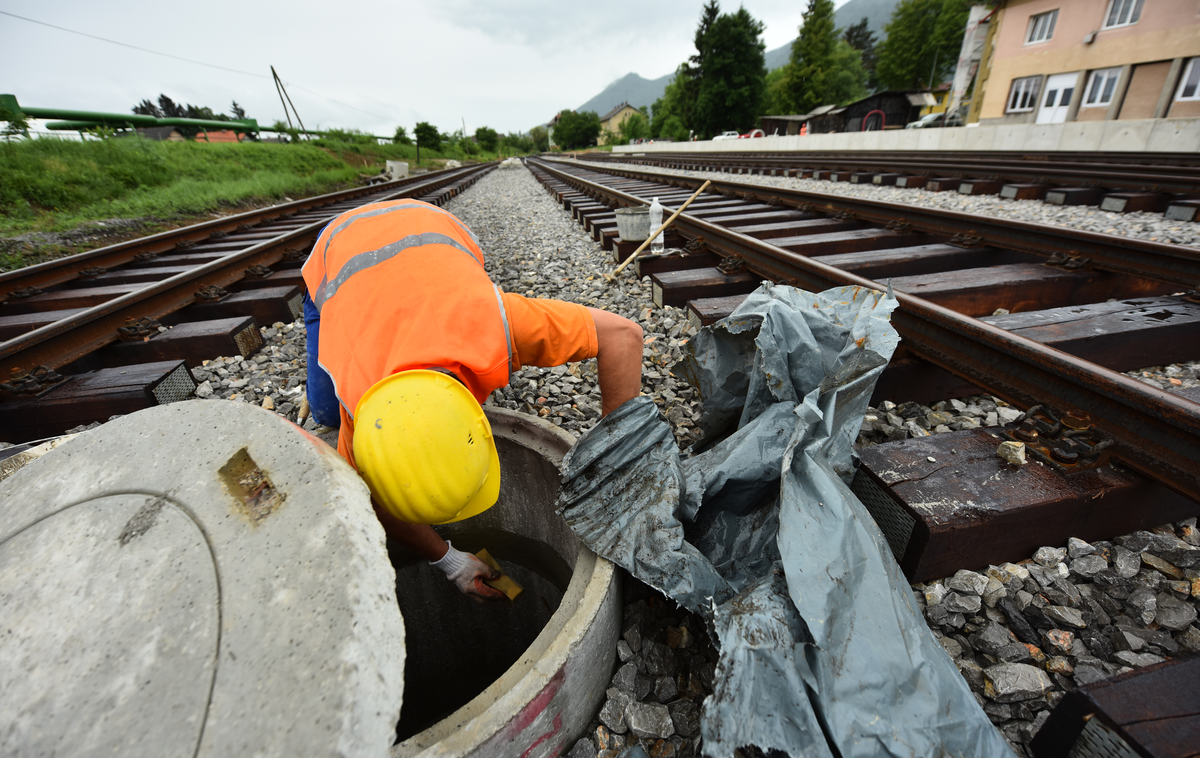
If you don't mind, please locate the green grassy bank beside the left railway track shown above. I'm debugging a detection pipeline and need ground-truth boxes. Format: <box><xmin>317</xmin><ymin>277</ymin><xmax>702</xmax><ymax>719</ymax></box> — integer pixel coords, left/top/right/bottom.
<box><xmin>0</xmin><ymin>137</ymin><xmax>523</xmax><ymax>236</ymax></box>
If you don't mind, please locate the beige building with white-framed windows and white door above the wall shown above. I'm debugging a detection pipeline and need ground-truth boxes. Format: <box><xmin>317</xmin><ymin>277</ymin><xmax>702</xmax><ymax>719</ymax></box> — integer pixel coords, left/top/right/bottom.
<box><xmin>970</xmin><ymin>0</ymin><xmax>1200</xmax><ymax>125</ymax></box>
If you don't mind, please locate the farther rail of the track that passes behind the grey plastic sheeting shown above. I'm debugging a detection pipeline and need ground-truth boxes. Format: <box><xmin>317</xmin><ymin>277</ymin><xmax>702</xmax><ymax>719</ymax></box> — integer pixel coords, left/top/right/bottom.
<box><xmin>549</xmin><ymin>161</ymin><xmax>1200</xmax><ymax>289</ymax></box>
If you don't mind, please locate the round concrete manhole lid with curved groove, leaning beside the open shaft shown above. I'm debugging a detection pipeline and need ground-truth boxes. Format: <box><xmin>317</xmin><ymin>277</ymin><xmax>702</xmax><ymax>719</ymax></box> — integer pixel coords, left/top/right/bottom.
<box><xmin>0</xmin><ymin>401</ymin><xmax>404</xmax><ymax>756</ymax></box>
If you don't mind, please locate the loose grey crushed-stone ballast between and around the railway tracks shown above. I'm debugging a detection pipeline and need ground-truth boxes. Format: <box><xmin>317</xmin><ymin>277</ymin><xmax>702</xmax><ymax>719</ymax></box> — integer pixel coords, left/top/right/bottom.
<box><xmin>37</xmin><ymin>169</ymin><xmax>1200</xmax><ymax>758</ymax></box>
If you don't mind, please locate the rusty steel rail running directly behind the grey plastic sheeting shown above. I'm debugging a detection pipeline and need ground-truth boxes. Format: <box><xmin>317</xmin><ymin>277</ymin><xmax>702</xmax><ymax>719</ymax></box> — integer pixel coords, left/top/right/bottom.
<box><xmin>535</xmin><ymin>161</ymin><xmax>1200</xmax><ymax>501</ymax></box>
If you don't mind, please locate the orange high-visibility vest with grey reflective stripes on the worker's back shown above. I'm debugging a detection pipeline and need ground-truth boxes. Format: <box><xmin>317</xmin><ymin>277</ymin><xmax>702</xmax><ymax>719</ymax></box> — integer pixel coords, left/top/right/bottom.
<box><xmin>304</xmin><ymin>200</ymin><xmax>512</xmax><ymax>419</ymax></box>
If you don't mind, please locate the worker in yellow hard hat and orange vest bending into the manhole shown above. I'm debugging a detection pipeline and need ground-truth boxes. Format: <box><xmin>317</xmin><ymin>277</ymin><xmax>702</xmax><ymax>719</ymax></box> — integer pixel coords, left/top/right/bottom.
<box><xmin>304</xmin><ymin>200</ymin><xmax>642</xmax><ymax>602</ymax></box>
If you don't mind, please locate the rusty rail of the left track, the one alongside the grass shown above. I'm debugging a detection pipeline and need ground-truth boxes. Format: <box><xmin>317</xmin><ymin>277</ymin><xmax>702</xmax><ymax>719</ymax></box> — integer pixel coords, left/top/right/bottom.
<box><xmin>0</xmin><ymin>163</ymin><xmax>477</xmax><ymax>296</ymax></box>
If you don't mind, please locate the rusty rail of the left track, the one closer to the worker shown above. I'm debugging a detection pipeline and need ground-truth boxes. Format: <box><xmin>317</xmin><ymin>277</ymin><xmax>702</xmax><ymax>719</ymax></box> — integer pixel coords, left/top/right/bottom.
<box><xmin>0</xmin><ymin>162</ymin><xmax>496</xmax><ymax>378</ymax></box>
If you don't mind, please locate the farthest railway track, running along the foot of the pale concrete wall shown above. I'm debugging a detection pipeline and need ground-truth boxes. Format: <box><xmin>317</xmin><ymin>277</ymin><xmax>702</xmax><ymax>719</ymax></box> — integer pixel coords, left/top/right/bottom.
<box><xmin>581</xmin><ymin>151</ymin><xmax>1200</xmax><ymax>221</ymax></box>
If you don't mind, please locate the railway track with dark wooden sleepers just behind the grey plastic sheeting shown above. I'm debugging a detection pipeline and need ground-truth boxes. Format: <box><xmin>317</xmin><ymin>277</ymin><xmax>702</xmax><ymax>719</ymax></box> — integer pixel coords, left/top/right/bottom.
<box><xmin>529</xmin><ymin>160</ymin><xmax>1200</xmax><ymax>573</ymax></box>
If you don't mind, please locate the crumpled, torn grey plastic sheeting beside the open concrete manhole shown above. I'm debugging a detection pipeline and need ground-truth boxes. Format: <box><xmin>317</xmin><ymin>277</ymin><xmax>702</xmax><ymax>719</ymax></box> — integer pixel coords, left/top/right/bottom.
<box><xmin>558</xmin><ymin>284</ymin><xmax>1012</xmax><ymax>758</ymax></box>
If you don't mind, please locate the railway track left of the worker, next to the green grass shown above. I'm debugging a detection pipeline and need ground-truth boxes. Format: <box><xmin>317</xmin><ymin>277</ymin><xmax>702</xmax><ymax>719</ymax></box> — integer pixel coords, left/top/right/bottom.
<box><xmin>0</xmin><ymin>163</ymin><xmax>496</xmax><ymax>443</ymax></box>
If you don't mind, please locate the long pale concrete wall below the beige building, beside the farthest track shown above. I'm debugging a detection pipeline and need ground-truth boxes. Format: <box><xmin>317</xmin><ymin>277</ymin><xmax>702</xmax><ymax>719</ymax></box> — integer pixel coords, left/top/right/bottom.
<box><xmin>612</xmin><ymin>119</ymin><xmax>1200</xmax><ymax>154</ymax></box>
